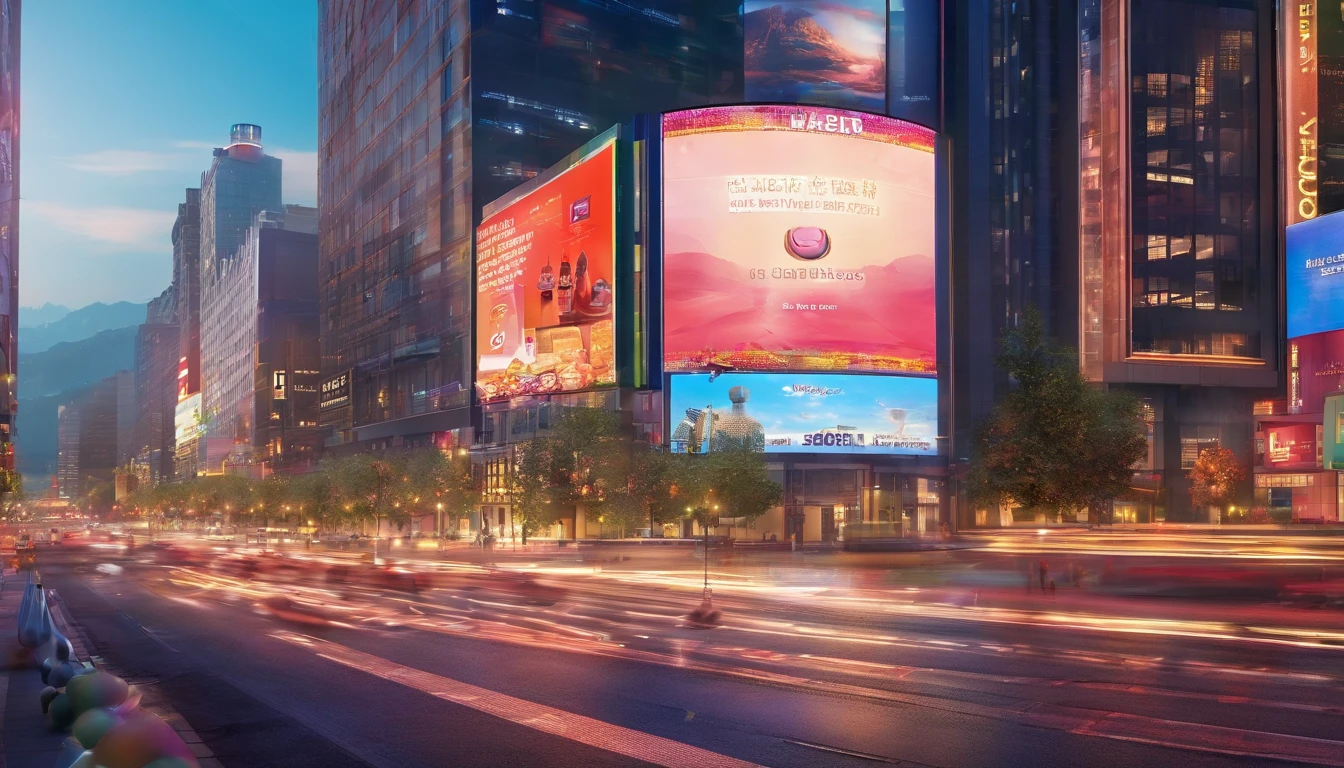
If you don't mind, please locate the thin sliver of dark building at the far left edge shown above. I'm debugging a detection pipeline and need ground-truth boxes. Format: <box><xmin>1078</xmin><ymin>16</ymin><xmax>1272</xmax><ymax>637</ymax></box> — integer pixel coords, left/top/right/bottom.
<box><xmin>0</xmin><ymin>0</ymin><xmax>22</xmax><ymax>486</ymax></box>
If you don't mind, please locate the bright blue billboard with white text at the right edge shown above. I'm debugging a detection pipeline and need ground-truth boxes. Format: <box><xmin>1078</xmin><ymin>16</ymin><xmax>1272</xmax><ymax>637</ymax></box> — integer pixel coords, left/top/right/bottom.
<box><xmin>1284</xmin><ymin>211</ymin><xmax>1344</xmax><ymax>339</ymax></box>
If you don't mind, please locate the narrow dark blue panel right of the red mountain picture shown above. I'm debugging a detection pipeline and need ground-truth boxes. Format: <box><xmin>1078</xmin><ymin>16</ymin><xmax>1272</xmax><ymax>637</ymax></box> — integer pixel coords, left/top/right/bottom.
<box><xmin>886</xmin><ymin>0</ymin><xmax>942</xmax><ymax>125</ymax></box>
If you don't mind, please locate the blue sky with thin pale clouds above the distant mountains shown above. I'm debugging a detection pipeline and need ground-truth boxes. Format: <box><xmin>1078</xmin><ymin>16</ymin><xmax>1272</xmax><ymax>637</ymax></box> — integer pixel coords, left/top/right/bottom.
<box><xmin>19</xmin><ymin>0</ymin><xmax>317</xmax><ymax>308</ymax></box>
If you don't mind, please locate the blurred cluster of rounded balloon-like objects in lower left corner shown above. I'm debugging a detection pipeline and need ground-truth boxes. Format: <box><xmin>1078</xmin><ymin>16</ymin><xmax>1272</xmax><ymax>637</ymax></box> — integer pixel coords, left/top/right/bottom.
<box><xmin>19</xmin><ymin>576</ymin><xmax>199</xmax><ymax>768</ymax></box>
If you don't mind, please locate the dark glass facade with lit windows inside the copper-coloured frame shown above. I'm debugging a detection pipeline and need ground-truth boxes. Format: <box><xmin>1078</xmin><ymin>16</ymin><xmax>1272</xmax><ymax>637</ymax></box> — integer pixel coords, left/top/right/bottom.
<box><xmin>1129</xmin><ymin>0</ymin><xmax>1277</xmax><ymax>359</ymax></box>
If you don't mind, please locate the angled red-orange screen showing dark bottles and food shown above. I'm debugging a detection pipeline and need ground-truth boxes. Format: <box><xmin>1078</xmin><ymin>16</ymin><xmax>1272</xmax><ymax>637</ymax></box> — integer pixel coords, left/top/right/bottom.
<box><xmin>476</xmin><ymin>129</ymin><xmax>617</xmax><ymax>402</ymax></box>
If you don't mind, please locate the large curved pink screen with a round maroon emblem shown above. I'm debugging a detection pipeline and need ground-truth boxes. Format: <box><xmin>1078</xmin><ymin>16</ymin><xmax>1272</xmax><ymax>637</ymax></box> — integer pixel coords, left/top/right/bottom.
<box><xmin>663</xmin><ymin>105</ymin><xmax>937</xmax><ymax>374</ymax></box>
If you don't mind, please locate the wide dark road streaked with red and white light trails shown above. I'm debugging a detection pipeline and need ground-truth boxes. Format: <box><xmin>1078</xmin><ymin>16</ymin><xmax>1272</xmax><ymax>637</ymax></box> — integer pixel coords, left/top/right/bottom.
<box><xmin>23</xmin><ymin>547</ymin><xmax>1344</xmax><ymax>768</ymax></box>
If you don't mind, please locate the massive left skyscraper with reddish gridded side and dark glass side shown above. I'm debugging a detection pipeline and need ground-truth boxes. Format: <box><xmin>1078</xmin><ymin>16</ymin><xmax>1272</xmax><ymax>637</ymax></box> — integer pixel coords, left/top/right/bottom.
<box><xmin>319</xmin><ymin>0</ymin><xmax>742</xmax><ymax>445</ymax></box>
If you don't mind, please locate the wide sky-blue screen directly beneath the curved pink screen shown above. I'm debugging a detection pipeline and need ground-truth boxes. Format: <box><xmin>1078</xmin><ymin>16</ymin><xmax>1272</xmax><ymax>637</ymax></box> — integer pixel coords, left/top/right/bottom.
<box><xmin>669</xmin><ymin>374</ymin><xmax>938</xmax><ymax>456</ymax></box>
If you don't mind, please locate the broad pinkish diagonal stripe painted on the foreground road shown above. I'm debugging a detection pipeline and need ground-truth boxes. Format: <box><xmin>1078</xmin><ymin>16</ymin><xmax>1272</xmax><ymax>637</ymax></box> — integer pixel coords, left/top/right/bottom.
<box><xmin>270</xmin><ymin>632</ymin><xmax>759</xmax><ymax>768</ymax></box>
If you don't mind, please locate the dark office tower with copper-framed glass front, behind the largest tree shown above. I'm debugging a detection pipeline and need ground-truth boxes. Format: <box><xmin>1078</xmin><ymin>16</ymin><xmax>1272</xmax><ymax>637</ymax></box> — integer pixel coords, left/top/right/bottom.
<box><xmin>948</xmin><ymin>0</ymin><xmax>1284</xmax><ymax>526</ymax></box>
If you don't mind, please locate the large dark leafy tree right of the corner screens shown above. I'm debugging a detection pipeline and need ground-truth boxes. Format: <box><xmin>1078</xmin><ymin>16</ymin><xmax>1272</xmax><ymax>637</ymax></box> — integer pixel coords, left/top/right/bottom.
<box><xmin>969</xmin><ymin>309</ymin><xmax>1146</xmax><ymax>521</ymax></box>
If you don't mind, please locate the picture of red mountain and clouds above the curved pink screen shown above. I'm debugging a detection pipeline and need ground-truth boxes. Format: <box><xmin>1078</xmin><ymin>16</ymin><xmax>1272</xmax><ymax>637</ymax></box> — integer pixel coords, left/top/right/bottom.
<box><xmin>742</xmin><ymin>0</ymin><xmax>887</xmax><ymax>112</ymax></box>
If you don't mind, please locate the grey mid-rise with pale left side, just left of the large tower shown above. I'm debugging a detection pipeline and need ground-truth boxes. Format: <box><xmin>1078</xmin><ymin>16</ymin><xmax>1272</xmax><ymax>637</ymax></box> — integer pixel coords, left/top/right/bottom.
<box><xmin>202</xmin><ymin>206</ymin><xmax>323</xmax><ymax>473</ymax></box>
